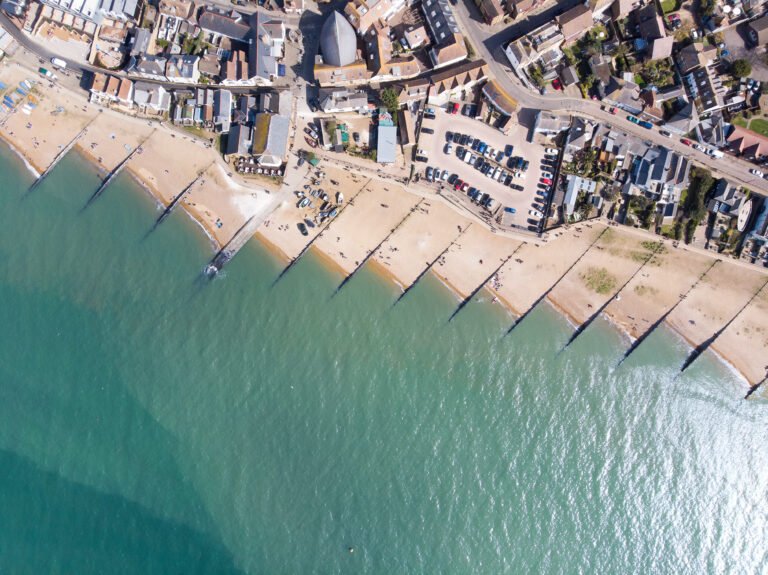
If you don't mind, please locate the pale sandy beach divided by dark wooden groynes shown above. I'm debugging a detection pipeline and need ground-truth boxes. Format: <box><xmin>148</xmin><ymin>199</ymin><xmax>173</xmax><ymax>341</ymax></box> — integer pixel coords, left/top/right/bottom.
<box><xmin>0</xmin><ymin>62</ymin><xmax>768</xmax><ymax>383</ymax></box>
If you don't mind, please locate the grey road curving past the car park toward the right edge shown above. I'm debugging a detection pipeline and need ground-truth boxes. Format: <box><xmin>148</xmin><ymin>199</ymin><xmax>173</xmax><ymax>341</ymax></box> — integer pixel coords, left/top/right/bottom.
<box><xmin>454</xmin><ymin>0</ymin><xmax>768</xmax><ymax>195</ymax></box>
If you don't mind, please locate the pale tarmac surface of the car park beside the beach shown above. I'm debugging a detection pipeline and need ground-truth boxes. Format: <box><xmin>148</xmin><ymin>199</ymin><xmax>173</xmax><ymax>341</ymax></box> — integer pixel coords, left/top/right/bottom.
<box><xmin>417</xmin><ymin>109</ymin><xmax>552</xmax><ymax>226</ymax></box>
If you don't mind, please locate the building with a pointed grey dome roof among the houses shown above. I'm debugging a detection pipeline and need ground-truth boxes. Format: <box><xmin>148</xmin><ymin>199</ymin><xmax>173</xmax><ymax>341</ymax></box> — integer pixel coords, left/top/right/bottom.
<box><xmin>315</xmin><ymin>12</ymin><xmax>371</xmax><ymax>86</ymax></box>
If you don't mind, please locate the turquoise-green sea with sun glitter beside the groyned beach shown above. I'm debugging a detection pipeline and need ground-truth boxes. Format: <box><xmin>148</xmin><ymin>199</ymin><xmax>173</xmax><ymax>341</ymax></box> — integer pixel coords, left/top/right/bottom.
<box><xmin>0</xmin><ymin>141</ymin><xmax>768</xmax><ymax>575</ymax></box>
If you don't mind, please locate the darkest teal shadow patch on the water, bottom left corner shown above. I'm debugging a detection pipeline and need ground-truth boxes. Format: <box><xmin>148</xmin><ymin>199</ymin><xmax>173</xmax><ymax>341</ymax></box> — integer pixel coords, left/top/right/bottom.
<box><xmin>0</xmin><ymin>450</ymin><xmax>241</xmax><ymax>575</ymax></box>
